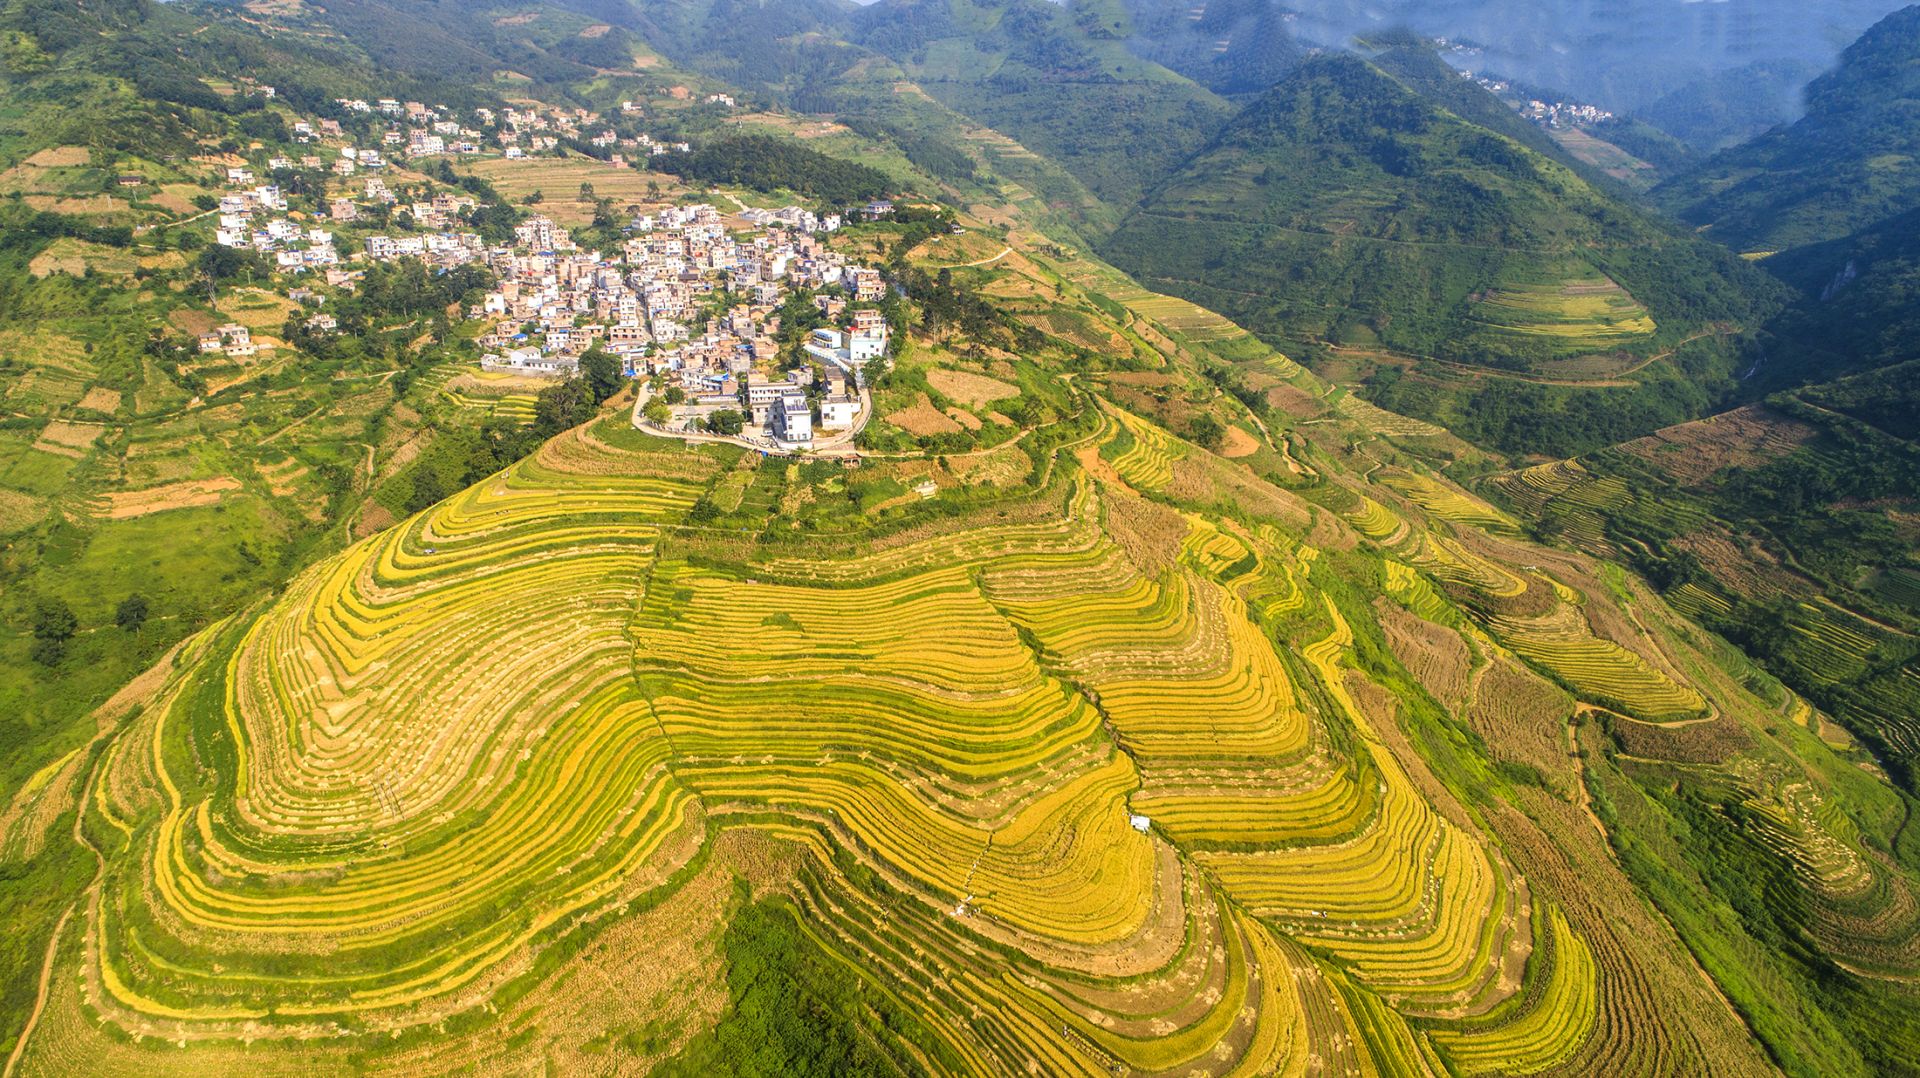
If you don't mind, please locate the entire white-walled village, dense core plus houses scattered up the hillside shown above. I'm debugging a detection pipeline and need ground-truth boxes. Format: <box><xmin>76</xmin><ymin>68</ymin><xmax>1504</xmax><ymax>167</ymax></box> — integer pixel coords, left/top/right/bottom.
<box><xmin>198</xmin><ymin>87</ymin><xmax>893</xmax><ymax>452</ymax></box>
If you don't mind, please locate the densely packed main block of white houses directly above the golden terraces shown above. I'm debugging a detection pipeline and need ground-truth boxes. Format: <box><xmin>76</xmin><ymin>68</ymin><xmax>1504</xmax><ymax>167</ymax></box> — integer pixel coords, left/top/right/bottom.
<box><xmin>468</xmin><ymin>204</ymin><xmax>889</xmax><ymax>446</ymax></box>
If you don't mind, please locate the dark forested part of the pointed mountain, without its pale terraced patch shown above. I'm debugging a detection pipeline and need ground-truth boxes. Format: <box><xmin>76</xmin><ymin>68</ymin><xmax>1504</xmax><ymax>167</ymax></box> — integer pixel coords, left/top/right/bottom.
<box><xmin>1108</xmin><ymin>54</ymin><xmax>1753</xmax><ymax>365</ymax></box>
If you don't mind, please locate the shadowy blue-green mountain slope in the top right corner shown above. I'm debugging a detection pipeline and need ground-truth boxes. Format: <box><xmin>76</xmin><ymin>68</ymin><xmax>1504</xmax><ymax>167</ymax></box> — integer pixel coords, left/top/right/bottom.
<box><xmin>1655</xmin><ymin>6</ymin><xmax>1920</xmax><ymax>252</ymax></box>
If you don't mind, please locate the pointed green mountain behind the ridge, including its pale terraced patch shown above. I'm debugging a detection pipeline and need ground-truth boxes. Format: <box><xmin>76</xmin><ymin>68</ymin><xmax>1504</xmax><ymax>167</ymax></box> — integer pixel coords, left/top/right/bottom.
<box><xmin>1104</xmin><ymin>56</ymin><xmax>1778</xmax><ymax>450</ymax></box>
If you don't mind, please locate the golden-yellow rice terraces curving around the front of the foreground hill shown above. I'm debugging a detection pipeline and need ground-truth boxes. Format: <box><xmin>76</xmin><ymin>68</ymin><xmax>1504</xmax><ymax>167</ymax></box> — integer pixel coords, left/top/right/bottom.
<box><xmin>11</xmin><ymin>405</ymin><xmax>1635</xmax><ymax>1074</ymax></box>
